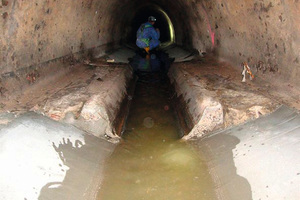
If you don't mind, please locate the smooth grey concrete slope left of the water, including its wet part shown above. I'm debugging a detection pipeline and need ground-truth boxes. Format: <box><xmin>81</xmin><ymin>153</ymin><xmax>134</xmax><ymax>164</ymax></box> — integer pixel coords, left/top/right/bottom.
<box><xmin>0</xmin><ymin>113</ymin><xmax>115</xmax><ymax>200</ymax></box>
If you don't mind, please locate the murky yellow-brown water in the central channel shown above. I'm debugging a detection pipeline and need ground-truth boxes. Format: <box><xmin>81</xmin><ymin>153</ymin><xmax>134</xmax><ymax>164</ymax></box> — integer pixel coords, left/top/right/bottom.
<box><xmin>98</xmin><ymin>73</ymin><xmax>216</xmax><ymax>200</ymax></box>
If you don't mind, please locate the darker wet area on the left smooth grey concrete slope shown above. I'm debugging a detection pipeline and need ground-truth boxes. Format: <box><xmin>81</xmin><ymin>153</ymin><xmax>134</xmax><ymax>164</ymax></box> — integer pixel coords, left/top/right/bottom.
<box><xmin>39</xmin><ymin>135</ymin><xmax>114</xmax><ymax>200</ymax></box>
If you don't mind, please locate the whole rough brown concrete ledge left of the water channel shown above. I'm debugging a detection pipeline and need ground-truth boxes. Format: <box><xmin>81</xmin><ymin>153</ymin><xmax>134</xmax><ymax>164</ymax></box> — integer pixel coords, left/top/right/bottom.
<box><xmin>0</xmin><ymin>58</ymin><xmax>132</xmax><ymax>141</ymax></box>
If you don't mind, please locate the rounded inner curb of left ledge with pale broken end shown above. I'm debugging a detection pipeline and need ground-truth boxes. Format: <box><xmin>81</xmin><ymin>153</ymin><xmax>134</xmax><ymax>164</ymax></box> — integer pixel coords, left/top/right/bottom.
<box><xmin>72</xmin><ymin>67</ymin><xmax>132</xmax><ymax>141</ymax></box>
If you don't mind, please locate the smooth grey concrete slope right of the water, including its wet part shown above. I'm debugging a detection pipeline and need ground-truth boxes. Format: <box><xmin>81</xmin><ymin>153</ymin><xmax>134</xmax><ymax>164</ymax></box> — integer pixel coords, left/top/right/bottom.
<box><xmin>194</xmin><ymin>106</ymin><xmax>300</xmax><ymax>200</ymax></box>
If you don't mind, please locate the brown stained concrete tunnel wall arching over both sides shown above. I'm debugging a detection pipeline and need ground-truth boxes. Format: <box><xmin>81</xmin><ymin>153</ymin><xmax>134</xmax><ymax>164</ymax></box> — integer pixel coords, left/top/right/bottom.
<box><xmin>0</xmin><ymin>0</ymin><xmax>300</xmax><ymax>85</ymax></box>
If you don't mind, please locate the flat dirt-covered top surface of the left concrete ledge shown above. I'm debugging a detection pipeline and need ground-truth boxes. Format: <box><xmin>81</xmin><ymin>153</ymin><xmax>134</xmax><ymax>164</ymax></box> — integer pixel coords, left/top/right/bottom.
<box><xmin>0</xmin><ymin>58</ymin><xmax>130</xmax><ymax>124</ymax></box>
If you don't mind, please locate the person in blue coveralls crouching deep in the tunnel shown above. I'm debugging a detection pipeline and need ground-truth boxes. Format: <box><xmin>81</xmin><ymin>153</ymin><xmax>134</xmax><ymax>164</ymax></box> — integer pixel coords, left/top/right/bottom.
<box><xmin>136</xmin><ymin>16</ymin><xmax>160</xmax><ymax>54</ymax></box>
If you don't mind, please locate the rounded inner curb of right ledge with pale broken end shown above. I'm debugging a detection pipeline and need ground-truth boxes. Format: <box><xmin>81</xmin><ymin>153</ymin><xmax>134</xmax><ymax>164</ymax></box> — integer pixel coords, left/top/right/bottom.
<box><xmin>169</xmin><ymin>67</ymin><xmax>223</xmax><ymax>139</ymax></box>
